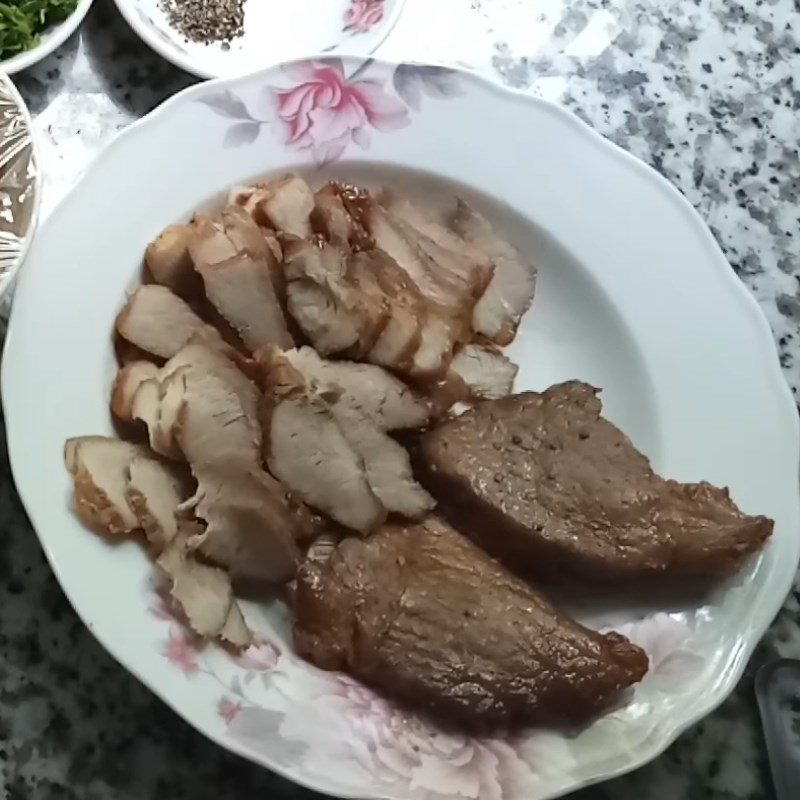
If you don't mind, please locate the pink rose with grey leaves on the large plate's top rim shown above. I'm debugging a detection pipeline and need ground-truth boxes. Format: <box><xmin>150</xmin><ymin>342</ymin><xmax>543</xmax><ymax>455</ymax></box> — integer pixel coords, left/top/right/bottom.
<box><xmin>199</xmin><ymin>60</ymin><xmax>461</xmax><ymax>166</ymax></box>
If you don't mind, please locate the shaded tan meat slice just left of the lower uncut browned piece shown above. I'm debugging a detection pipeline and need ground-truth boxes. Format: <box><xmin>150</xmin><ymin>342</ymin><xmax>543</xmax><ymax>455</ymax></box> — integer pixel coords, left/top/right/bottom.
<box><xmin>185</xmin><ymin>455</ymin><xmax>310</xmax><ymax>582</ymax></box>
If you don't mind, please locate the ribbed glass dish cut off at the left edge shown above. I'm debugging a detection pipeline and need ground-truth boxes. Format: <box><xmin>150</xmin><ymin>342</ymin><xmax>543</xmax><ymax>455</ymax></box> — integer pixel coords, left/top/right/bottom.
<box><xmin>0</xmin><ymin>73</ymin><xmax>41</xmax><ymax>297</ymax></box>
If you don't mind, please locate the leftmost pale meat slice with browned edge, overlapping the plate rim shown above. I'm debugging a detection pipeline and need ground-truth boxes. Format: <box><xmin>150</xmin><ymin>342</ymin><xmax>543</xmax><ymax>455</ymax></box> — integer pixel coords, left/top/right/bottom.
<box><xmin>64</xmin><ymin>436</ymin><xmax>148</xmax><ymax>537</ymax></box>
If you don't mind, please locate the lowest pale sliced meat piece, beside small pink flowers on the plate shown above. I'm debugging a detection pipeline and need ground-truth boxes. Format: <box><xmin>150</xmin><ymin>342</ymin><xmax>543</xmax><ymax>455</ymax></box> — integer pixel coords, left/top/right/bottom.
<box><xmin>156</xmin><ymin>538</ymin><xmax>253</xmax><ymax>650</ymax></box>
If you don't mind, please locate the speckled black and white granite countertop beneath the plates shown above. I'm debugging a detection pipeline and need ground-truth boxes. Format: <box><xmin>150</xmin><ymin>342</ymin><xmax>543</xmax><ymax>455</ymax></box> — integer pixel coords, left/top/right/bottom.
<box><xmin>0</xmin><ymin>0</ymin><xmax>800</xmax><ymax>800</ymax></box>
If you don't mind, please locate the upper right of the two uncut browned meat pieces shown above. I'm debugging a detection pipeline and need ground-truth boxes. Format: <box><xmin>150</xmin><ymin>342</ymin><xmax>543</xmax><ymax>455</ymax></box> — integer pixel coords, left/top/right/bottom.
<box><xmin>420</xmin><ymin>381</ymin><xmax>773</xmax><ymax>581</ymax></box>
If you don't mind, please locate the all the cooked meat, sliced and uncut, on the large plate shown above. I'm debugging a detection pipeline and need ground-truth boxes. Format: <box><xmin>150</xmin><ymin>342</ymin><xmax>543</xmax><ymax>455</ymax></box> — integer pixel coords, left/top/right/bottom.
<box><xmin>65</xmin><ymin>175</ymin><xmax>772</xmax><ymax>727</ymax></box>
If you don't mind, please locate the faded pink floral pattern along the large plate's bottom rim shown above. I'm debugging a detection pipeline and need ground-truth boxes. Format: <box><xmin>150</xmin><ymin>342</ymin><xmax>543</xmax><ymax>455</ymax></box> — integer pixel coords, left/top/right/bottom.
<box><xmin>151</xmin><ymin>564</ymin><xmax>704</xmax><ymax>800</ymax></box>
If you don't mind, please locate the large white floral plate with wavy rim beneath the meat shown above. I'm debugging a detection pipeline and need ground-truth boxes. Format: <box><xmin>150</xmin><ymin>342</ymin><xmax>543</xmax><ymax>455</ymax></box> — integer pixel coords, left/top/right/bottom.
<box><xmin>2</xmin><ymin>60</ymin><xmax>800</xmax><ymax>800</ymax></box>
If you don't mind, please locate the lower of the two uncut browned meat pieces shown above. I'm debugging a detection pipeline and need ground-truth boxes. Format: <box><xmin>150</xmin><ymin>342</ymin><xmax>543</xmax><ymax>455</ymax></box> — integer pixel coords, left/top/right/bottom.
<box><xmin>294</xmin><ymin>517</ymin><xmax>647</xmax><ymax>727</ymax></box>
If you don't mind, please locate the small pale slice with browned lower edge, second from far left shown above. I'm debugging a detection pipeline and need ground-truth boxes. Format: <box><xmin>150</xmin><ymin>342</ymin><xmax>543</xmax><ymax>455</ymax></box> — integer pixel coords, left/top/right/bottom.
<box><xmin>125</xmin><ymin>455</ymin><xmax>189</xmax><ymax>553</ymax></box>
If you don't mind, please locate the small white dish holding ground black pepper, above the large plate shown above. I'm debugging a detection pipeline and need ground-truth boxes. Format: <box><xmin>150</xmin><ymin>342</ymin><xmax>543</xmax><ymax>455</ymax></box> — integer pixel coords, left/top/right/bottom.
<box><xmin>115</xmin><ymin>0</ymin><xmax>405</xmax><ymax>78</ymax></box>
